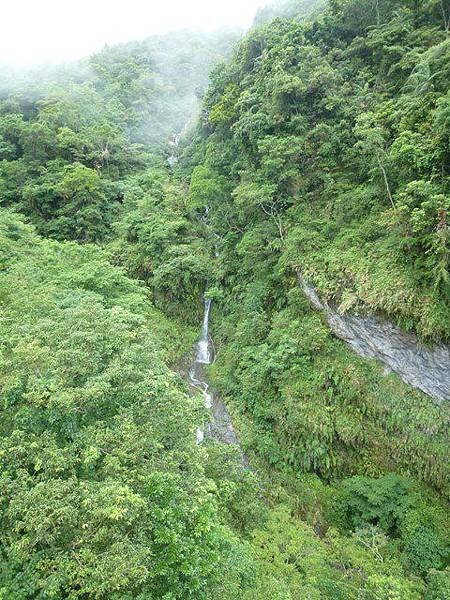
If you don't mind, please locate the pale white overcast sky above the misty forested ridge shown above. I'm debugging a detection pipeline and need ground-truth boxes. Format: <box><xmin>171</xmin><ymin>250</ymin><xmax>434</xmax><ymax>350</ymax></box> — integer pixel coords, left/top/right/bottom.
<box><xmin>0</xmin><ymin>0</ymin><xmax>270</xmax><ymax>65</ymax></box>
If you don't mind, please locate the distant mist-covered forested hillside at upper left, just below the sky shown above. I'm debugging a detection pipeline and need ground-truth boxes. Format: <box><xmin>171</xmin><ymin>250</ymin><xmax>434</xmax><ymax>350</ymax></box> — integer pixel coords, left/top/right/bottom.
<box><xmin>0</xmin><ymin>32</ymin><xmax>236</xmax><ymax>244</ymax></box>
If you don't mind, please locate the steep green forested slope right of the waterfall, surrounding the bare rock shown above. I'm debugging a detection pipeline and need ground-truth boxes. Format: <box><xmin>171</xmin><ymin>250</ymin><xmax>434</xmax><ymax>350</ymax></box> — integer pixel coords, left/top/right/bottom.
<box><xmin>173</xmin><ymin>0</ymin><xmax>450</xmax><ymax>600</ymax></box>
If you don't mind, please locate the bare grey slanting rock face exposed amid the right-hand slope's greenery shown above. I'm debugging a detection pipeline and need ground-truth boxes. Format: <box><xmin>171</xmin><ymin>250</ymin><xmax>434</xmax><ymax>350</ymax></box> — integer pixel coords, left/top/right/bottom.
<box><xmin>298</xmin><ymin>273</ymin><xmax>450</xmax><ymax>401</ymax></box>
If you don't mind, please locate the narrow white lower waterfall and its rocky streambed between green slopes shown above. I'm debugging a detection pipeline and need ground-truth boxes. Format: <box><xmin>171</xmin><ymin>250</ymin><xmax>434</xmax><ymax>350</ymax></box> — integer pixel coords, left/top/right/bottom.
<box><xmin>188</xmin><ymin>299</ymin><xmax>248</xmax><ymax>466</ymax></box>
